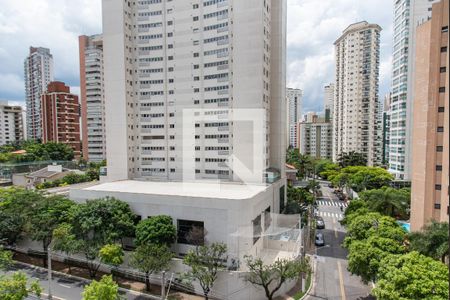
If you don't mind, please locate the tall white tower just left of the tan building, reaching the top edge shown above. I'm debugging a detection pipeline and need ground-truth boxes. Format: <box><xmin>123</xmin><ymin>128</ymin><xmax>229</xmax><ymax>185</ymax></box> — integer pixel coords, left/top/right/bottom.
<box><xmin>388</xmin><ymin>0</ymin><xmax>437</xmax><ymax>180</ymax></box>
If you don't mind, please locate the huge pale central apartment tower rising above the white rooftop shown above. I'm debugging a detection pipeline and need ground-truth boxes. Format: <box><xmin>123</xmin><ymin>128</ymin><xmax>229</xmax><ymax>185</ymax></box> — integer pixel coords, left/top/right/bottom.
<box><xmin>103</xmin><ymin>0</ymin><xmax>286</xmax><ymax>181</ymax></box>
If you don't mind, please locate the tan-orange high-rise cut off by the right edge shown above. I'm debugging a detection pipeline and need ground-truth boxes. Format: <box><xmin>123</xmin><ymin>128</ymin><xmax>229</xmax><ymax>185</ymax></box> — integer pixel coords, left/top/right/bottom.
<box><xmin>411</xmin><ymin>0</ymin><xmax>450</xmax><ymax>231</ymax></box>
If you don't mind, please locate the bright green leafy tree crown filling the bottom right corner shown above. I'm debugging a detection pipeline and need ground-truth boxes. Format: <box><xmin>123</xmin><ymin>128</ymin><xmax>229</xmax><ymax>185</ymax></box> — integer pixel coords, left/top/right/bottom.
<box><xmin>372</xmin><ymin>251</ymin><xmax>449</xmax><ymax>300</ymax></box>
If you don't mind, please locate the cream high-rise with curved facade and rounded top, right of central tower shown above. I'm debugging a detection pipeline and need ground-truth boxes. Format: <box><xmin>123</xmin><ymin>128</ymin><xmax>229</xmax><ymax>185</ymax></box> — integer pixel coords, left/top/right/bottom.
<box><xmin>333</xmin><ymin>21</ymin><xmax>382</xmax><ymax>165</ymax></box>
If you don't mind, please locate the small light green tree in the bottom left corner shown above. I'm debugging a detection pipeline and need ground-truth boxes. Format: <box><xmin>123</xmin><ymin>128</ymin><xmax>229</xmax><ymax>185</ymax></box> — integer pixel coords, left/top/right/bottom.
<box><xmin>0</xmin><ymin>272</ymin><xmax>42</xmax><ymax>300</ymax></box>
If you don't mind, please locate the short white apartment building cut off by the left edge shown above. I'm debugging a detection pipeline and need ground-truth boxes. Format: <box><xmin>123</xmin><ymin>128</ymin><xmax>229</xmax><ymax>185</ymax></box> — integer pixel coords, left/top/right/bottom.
<box><xmin>0</xmin><ymin>102</ymin><xmax>24</xmax><ymax>146</ymax></box>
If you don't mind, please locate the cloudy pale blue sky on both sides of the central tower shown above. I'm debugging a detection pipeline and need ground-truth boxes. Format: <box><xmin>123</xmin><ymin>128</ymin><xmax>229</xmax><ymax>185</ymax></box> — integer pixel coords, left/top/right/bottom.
<box><xmin>0</xmin><ymin>0</ymin><xmax>393</xmax><ymax>113</ymax></box>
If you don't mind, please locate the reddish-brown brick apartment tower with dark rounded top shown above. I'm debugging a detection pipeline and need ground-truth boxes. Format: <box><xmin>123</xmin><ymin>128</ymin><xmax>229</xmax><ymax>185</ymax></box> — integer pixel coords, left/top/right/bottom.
<box><xmin>41</xmin><ymin>81</ymin><xmax>81</xmax><ymax>157</ymax></box>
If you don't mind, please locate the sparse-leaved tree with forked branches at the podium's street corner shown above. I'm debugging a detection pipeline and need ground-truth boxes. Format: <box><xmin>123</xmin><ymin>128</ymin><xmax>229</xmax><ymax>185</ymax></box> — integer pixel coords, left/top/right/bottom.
<box><xmin>245</xmin><ymin>256</ymin><xmax>311</xmax><ymax>300</ymax></box>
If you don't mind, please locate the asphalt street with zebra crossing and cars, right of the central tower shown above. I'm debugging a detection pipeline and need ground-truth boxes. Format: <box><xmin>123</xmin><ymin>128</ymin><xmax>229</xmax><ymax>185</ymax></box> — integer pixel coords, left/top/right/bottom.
<box><xmin>306</xmin><ymin>183</ymin><xmax>374</xmax><ymax>300</ymax></box>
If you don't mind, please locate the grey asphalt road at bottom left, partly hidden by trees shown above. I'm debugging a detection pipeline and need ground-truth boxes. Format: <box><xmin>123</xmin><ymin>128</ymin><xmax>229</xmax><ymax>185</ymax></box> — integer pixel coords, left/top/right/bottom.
<box><xmin>0</xmin><ymin>265</ymin><xmax>154</xmax><ymax>300</ymax></box>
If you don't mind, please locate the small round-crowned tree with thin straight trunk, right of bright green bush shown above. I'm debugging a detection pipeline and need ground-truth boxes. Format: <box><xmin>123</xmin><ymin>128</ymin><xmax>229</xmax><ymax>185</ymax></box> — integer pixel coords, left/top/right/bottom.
<box><xmin>130</xmin><ymin>244</ymin><xmax>173</xmax><ymax>292</ymax></box>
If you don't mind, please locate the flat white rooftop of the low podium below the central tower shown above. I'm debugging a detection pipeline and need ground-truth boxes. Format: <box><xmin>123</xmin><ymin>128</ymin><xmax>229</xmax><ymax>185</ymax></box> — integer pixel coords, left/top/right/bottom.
<box><xmin>79</xmin><ymin>180</ymin><xmax>268</xmax><ymax>200</ymax></box>
